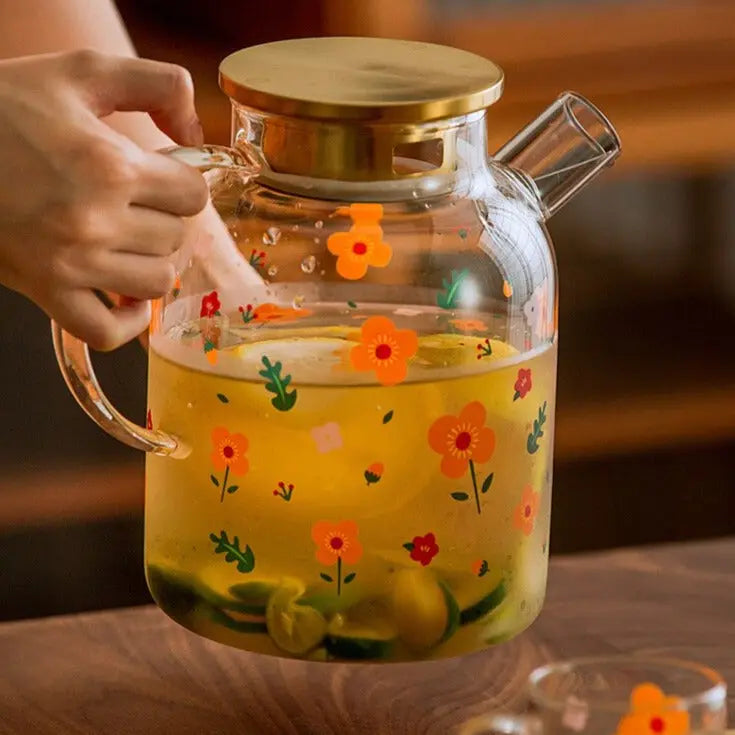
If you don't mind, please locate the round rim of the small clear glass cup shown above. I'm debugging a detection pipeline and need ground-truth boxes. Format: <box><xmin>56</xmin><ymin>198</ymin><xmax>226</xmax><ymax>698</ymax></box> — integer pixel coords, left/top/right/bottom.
<box><xmin>526</xmin><ymin>654</ymin><xmax>727</xmax><ymax>712</ymax></box>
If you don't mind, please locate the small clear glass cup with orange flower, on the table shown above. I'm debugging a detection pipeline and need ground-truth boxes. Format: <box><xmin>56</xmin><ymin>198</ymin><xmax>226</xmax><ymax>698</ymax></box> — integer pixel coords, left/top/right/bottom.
<box><xmin>459</xmin><ymin>656</ymin><xmax>727</xmax><ymax>735</ymax></box>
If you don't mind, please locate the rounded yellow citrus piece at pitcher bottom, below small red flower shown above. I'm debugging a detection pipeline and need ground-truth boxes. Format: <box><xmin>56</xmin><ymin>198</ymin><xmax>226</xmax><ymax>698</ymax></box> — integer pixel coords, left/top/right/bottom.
<box><xmin>392</xmin><ymin>569</ymin><xmax>458</xmax><ymax>651</ymax></box>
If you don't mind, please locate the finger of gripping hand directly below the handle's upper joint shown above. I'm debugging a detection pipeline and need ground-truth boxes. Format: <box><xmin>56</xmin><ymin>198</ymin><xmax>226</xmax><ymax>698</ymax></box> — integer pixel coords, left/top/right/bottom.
<box><xmin>131</xmin><ymin>153</ymin><xmax>209</xmax><ymax>217</ymax></box>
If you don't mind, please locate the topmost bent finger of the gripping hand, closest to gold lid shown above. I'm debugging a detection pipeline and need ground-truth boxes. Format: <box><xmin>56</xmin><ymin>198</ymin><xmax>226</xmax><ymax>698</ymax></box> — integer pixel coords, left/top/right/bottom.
<box><xmin>69</xmin><ymin>51</ymin><xmax>203</xmax><ymax>145</ymax></box>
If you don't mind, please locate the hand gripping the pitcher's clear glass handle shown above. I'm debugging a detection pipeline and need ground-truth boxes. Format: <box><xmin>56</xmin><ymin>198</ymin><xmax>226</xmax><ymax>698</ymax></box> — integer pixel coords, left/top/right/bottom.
<box><xmin>0</xmin><ymin>51</ymin><xmax>207</xmax><ymax>350</ymax></box>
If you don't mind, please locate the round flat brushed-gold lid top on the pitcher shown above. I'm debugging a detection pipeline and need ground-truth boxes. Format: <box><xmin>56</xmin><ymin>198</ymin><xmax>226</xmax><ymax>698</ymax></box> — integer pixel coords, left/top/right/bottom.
<box><xmin>219</xmin><ymin>37</ymin><xmax>503</xmax><ymax>123</ymax></box>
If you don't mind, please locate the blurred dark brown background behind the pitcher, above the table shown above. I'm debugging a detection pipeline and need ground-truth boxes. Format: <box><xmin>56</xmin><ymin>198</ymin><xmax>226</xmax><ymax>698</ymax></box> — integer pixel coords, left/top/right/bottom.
<box><xmin>0</xmin><ymin>0</ymin><xmax>735</xmax><ymax>619</ymax></box>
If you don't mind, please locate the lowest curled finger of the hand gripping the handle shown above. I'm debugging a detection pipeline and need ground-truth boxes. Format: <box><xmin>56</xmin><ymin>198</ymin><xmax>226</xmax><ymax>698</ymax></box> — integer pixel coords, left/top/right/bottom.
<box><xmin>44</xmin><ymin>290</ymin><xmax>151</xmax><ymax>352</ymax></box>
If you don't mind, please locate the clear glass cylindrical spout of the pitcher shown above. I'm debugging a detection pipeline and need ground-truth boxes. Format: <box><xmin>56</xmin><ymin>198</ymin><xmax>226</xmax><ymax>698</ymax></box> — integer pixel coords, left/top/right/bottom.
<box><xmin>493</xmin><ymin>92</ymin><xmax>620</xmax><ymax>219</ymax></box>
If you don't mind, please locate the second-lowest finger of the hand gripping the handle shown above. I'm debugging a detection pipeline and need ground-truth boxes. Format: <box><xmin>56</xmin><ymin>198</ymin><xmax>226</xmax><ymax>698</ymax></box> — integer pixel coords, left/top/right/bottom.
<box><xmin>83</xmin><ymin>251</ymin><xmax>176</xmax><ymax>299</ymax></box>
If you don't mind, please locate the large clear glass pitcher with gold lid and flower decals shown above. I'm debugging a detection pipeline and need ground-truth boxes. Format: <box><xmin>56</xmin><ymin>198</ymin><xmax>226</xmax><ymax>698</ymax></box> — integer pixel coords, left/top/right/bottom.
<box><xmin>53</xmin><ymin>38</ymin><xmax>619</xmax><ymax>662</ymax></box>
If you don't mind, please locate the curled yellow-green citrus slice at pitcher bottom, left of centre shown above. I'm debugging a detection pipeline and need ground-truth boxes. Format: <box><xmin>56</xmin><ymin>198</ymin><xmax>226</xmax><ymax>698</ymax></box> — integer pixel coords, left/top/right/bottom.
<box><xmin>265</xmin><ymin>580</ymin><xmax>327</xmax><ymax>656</ymax></box>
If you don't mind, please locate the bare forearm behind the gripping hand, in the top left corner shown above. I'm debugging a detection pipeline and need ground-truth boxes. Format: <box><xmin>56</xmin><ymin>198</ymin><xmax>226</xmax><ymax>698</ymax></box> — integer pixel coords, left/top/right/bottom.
<box><xmin>0</xmin><ymin>0</ymin><xmax>172</xmax><ymax>150</ymax></box>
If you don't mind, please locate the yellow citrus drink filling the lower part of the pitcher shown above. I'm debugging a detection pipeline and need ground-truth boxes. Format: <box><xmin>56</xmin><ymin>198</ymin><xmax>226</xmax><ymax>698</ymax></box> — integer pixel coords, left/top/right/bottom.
<box><xmin>146</xmin><ymin>314</ymin><xmax>556</xmax><ymax>661</ymax></box>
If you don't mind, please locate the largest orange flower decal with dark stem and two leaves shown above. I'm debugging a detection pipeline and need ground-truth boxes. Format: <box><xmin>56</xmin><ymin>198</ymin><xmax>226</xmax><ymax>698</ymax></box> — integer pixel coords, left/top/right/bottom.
<box><xmin>429</xmin><ymin>401</ymin><xmax>495</xmax><ymax>515</ymax></box>
